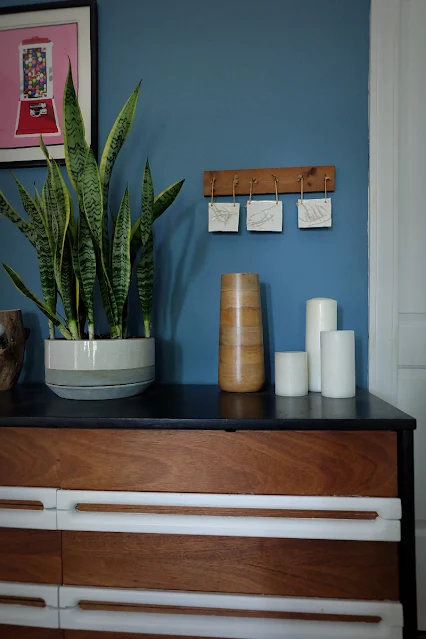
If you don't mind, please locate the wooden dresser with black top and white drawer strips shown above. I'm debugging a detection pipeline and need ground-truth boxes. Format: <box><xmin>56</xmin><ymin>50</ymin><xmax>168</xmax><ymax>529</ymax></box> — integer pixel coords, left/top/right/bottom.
<box><xmin>0</xmin><ymin>385</ymin><xmax>416</xmax><ymax>639</ymax></box>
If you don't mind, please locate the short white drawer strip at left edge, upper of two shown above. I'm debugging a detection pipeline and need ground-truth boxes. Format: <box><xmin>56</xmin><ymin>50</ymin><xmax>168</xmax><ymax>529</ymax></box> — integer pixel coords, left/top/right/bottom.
<box><xmin>0</xmin><ymin>486</ymin><xmax>57</xmax><ymax>530</ymax></box>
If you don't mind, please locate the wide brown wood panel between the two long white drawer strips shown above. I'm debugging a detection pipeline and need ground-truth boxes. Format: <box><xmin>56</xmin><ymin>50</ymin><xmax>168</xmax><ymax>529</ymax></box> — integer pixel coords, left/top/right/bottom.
<box><xmin>62</xmin><ymin>531</ymin><xmax>398</xmax><ymax>601</ymax></box>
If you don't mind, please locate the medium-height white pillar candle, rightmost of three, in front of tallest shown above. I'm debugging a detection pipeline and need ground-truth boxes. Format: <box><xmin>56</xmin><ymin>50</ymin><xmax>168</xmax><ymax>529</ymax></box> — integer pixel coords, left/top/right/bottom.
<box><xmin>321</xmin><ymin>331</ymin><xmax>355</xmax><ymax>398</ymax></box>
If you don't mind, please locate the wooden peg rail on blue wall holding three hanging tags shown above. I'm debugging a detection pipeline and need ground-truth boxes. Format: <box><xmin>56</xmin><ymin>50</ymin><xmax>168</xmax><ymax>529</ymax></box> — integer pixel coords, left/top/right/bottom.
<box><xmin>204</xmin><ymin>166</ymin><xmax>335</xmax><ymax>196</ymax></box>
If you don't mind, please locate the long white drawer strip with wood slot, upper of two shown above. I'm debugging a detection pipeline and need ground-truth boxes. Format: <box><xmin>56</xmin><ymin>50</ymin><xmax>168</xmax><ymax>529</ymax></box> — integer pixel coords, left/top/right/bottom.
<box><xmin>57</xmin><ymin>490</ymin><xmax>401</xmax><ymax>541</ymax></box>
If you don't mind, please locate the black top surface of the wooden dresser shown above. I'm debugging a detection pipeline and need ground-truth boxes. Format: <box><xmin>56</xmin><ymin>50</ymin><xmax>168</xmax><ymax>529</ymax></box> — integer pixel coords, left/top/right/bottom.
<box><xmin>0</xmin><ymin>384</ymin><xmax>416</xmax><ymax>431</ymax></box>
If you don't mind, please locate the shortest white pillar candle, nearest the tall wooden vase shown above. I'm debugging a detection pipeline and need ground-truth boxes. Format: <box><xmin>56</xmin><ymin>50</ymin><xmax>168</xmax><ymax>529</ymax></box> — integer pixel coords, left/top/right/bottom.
<box><xmin>275</xmin><ymin>351</ymin><xmax>308</xmax><ymax>397</ymax></box>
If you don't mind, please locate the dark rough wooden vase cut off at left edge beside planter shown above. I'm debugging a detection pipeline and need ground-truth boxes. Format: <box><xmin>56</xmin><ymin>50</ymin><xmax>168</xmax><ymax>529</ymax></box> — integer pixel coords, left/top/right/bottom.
<box><xmin>0</xmin><ymin>310</ymin><xmax>29</xmax><ymax>391</ymax></box>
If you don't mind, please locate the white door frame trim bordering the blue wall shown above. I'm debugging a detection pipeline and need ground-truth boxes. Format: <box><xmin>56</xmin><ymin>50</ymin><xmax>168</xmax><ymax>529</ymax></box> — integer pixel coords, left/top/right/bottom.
<box><xmin>368</xmin><ymin>0</ymin><xmax>405</xmax><ymax>404</ymax></box>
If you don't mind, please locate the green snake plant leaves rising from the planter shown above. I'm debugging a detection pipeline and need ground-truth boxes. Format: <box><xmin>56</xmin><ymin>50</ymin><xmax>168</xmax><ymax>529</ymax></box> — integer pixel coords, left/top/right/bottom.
<box><xmin>0</xmin><ymin>66</ymin><xmax>184</xmax><ymax>339</ymax></box>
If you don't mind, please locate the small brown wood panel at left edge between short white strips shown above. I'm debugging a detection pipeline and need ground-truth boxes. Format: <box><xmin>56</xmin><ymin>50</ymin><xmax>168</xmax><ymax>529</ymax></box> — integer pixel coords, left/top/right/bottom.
<box><xmin>0</xmin><ymin>528</ymin><xmax>62</xmax><ymax>594</ymax></box>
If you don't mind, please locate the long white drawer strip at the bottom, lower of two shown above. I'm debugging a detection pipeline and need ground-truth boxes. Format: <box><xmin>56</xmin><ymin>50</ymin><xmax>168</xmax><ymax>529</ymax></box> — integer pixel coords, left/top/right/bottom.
<box><xmin>59</xmin><ymin>586</ymin><xmax>402</xmax><ymax>639</ymax></box>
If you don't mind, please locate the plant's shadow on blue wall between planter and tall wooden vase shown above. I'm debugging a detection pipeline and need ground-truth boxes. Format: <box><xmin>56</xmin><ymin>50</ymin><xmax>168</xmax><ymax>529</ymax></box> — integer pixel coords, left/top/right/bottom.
<box><xmin>154</xmin><ymin>206</ymin><xmax>208</xmax><ymax>383</ymax></box>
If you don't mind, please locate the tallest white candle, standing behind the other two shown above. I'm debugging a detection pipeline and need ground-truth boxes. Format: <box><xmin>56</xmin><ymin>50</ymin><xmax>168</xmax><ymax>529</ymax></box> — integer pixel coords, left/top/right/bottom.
<box><xmin>306</xmin><ymin>297</ymin><xmax>337</xmax><ymax>393</ymax></box>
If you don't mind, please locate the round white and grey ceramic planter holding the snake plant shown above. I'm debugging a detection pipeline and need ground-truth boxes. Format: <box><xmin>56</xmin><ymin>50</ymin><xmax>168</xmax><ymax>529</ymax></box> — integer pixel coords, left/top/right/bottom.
<box><xmin>44</xmin><ymin>337</ymin><xmax>155</xmax><ymax>399</ymax></box>
